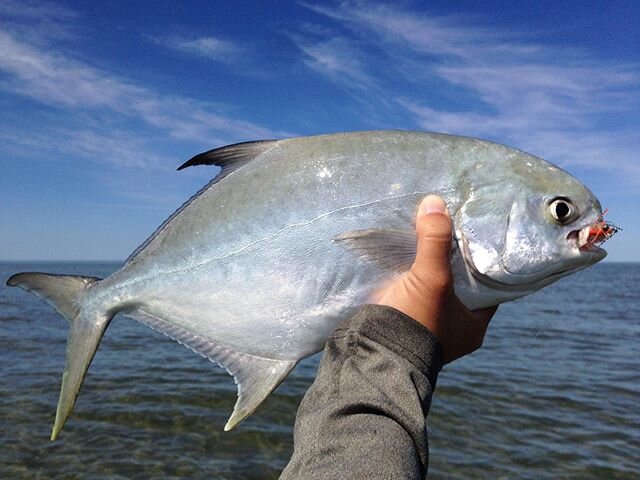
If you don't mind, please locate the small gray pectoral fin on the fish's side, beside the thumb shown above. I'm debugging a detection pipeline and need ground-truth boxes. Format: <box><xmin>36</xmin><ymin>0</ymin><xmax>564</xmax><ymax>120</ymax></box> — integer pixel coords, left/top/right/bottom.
<box><xmin>333</xmin><ymin>229</ymin><xmax>417</xmax><ymax>273</ymax></box>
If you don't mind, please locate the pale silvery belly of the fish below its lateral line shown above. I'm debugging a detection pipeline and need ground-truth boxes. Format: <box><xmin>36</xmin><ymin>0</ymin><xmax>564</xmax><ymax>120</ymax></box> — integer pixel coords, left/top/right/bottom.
<box><xmin>114</xmin><ymin>195</ymin><xmax>419</xmax><ymax>360</ymax></box>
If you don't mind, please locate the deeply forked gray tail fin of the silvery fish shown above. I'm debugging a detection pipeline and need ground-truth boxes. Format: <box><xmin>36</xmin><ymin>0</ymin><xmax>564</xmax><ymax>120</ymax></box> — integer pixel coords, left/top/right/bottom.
<box><xmin>7</xmin><ymin>272</ymin><xmax>115</xmax><ymax>440</ymax></box>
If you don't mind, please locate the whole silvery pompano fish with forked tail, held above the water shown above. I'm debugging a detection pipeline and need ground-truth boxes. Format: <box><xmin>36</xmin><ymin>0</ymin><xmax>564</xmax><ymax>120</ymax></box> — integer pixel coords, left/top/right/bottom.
<box><xmin>7</xmin><ymin>131</ymin><xmax>606</xmax><ymax>440</ymax></box>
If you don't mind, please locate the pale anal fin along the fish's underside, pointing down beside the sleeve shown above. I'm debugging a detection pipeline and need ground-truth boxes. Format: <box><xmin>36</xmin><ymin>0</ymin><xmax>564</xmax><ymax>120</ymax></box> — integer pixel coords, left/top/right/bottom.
<box><xmin>127</xmin><ymin>310</ymin><xmax>297</xmax><ymax>431</ymax></box>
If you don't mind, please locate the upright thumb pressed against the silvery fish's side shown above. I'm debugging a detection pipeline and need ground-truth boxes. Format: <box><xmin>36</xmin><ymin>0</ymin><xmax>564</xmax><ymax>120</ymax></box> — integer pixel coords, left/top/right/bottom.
<box><xmin>412</xmin><ymin>195</ymin><xmax>452</xmax><ymax>286</ymax></box>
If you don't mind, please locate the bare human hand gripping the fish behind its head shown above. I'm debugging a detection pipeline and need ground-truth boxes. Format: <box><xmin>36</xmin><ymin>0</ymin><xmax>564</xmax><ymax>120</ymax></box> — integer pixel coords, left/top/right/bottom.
<box><xmin>377</xmin><ymin>195</ymin><xmax>498</xmax><ymax>363</ymax></box>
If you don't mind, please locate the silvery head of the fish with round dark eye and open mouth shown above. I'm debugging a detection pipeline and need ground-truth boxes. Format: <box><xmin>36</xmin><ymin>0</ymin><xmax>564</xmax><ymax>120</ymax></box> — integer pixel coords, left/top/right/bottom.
<box><xmin>456</xmin><ymin>154</ymin><xmax>606</xmax><ymax>291</ymax></box>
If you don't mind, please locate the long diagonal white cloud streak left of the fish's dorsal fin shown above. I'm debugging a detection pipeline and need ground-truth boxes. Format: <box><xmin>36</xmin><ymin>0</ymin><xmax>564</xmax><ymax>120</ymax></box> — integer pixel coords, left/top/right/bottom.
<box><xmin>0</xmin><ymin>30</ymin><xmax>278</xmax><ymax>142</ymax></box>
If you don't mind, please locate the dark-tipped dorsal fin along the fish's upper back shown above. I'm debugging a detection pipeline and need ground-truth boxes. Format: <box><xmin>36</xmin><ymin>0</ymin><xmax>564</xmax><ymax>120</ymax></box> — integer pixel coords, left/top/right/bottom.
<box><xmin>125</xmin><ymin>140</ymin><xmax>276</xmax><ymax>265</ymax></box>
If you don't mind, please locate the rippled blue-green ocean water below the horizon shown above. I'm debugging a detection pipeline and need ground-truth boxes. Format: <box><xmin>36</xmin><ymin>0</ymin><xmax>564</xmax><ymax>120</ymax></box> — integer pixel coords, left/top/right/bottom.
<box><xmin>0</xmin><ymin>263</ymin><xmax>640</xmax><ymax>480</ymax></box>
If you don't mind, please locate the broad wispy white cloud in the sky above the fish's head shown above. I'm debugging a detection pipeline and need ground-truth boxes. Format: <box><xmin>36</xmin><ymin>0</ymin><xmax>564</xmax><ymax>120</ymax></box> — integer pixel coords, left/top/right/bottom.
<box><xmin>301</xmin><ymin>2</ymin><xmax>640</xmax><ymax>183</ymax></box>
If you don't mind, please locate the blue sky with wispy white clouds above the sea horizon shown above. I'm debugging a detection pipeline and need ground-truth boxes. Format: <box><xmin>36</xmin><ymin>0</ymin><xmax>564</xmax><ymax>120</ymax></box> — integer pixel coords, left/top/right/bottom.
<box><xmin>0</xmin><ymin>0</ymin><xmax>640</xmax><ymax>261</ymax></box>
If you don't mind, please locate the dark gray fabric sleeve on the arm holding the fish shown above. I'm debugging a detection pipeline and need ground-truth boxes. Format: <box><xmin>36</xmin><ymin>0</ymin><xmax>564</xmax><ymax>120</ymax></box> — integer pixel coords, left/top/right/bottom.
<box><xmin>280</xmin><ymin>305</ymin><xmax>442</xmax><ymax>480</ymax></box>
